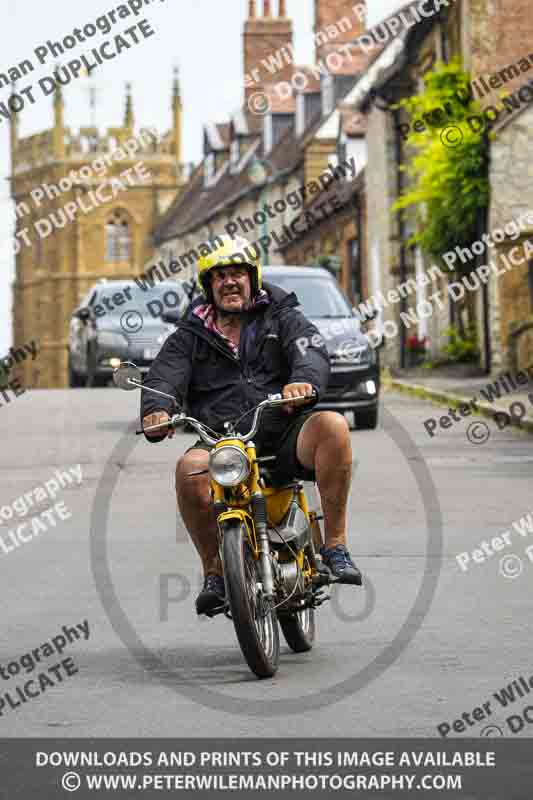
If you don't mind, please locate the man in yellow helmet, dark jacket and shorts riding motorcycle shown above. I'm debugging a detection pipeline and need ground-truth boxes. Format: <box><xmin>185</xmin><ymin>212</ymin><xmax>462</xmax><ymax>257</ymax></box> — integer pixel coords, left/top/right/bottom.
<box><xmin>141</xmin><ymin>236</ymin><xmax>362</xmax><ymax>614</ymax></box>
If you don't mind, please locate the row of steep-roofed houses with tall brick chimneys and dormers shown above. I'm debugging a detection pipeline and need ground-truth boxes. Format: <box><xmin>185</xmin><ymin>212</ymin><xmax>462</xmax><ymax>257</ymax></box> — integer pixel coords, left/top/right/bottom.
<box><xmin>154</xmin><ymin>0</ymin><xmax>367</xmax><ymax>284</ymax></box>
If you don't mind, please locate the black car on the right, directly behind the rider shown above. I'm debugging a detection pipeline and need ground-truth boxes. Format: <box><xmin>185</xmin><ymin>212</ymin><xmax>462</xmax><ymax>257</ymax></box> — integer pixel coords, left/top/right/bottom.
<box><xmin>263</xmin><ymin>266</ymin><xmax>380</xmax><ymax>429</ymax></box>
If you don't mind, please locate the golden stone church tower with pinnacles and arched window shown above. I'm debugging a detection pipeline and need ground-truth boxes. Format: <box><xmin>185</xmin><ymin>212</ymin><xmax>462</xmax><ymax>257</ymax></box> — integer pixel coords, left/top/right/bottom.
<box><xmin>10</xmin><ymin>75</ymin><xmax>188</xmax><ymax>388</ymax></box>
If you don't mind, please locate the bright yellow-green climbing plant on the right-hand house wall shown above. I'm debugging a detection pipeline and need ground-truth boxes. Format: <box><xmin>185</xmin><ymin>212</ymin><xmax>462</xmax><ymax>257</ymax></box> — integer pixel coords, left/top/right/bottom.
<box><xmin>393</xmin><ymin>59</ymin><xmax>489</xmax><ymax>266</ymax></box>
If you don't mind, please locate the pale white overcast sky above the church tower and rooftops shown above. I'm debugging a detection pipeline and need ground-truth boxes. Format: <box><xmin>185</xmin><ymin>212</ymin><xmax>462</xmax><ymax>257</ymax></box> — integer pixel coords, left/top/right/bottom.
<box><xmin>0</xmin><ymin>0</ymin><xmax>405</xmax><ymax>357</ymax></box>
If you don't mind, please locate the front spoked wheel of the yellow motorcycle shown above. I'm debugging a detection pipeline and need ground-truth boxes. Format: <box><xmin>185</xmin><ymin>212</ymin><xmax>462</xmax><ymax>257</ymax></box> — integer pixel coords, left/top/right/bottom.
<box><xmin>224</xmin><ymin>523</ymin><xmax>279</xmax><ymax>678</ymax></box>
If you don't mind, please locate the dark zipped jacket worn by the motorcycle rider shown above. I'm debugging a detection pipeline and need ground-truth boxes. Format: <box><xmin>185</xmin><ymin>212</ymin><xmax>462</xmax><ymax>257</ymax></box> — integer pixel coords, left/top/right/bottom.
<box><xmin>141</xmin><ymin>283</ymin><xmax>330</xmax><ymax>445</ymax></box>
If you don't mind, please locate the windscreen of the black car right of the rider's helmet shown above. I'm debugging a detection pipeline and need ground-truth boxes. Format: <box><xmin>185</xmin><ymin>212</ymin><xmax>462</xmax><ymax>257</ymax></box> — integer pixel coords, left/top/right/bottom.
<box><xmin>265</xmin><ymin>273</ymin><xmax>352</xmax><ymax>319</ymax></box>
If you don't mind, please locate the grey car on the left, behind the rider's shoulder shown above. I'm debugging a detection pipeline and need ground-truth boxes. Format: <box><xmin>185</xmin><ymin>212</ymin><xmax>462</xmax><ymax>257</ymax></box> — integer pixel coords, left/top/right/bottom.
<box><xmin>68</xmin><ymin>280</ymin><xmax>189</xmax><ymax>387</ymax></box>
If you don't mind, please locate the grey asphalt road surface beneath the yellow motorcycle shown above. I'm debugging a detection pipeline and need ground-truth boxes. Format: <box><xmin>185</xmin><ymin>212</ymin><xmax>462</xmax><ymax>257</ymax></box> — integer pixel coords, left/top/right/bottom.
<box><xmin>0</xmin><ymin>388</ymin><xmax>533</xmax><ymax>737</ymax></box>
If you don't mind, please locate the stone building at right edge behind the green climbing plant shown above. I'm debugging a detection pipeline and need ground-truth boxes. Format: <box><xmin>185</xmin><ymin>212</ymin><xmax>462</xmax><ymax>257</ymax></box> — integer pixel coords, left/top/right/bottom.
<box><xmin>345</xmin><ymin>0</ymin><xmax>533</xmax><ymax>372</ymax></box>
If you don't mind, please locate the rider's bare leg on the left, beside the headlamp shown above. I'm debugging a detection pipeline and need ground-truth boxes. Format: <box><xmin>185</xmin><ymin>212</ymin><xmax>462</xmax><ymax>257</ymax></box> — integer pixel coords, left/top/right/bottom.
<box><xmin>176</xmin><ymin>450</ymin><xmax>222</xmax><ymax>576</ymax></box>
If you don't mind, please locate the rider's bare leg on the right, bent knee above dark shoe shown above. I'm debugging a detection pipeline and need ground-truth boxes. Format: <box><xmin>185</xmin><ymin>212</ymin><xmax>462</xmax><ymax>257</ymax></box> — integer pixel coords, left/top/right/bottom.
<box><xmin>296</xmin><ymin>411</ymin><xmax>352</xmax><ymax>548</ymax></box>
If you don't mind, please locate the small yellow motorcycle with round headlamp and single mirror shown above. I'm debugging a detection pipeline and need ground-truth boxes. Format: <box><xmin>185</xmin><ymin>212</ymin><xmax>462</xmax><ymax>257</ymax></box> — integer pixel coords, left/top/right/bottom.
<box><xmin>113</xmin><ymin>362</ymin><xmax>336</xmax><ymax>678</ymax></box>
